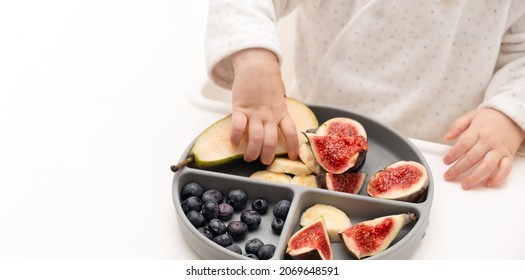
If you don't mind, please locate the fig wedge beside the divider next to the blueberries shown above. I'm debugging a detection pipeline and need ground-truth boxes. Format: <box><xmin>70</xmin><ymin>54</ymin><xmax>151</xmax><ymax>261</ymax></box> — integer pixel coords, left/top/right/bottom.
<box><xmin>286</xmin><ymin>217</ymin><xmax>334</xmax><ymax>260</ymax></box>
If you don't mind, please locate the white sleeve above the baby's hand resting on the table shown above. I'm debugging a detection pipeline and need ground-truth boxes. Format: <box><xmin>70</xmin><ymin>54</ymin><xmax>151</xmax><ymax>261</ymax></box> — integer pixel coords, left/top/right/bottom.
<box><xmin>481</xmin><ymin>12</ymin><xmax>525</xmax><ymax>130</ymax></box>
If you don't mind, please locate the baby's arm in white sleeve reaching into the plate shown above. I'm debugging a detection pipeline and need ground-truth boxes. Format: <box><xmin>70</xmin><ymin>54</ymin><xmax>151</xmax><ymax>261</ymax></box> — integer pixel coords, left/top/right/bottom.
<box><xmin>205</xmin><ymin>0</ymin><xmax>300</xmax><ymax>164</ymax></box>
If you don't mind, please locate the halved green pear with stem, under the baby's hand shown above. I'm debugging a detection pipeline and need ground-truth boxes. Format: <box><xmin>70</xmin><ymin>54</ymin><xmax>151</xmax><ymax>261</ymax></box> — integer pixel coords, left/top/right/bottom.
<box><xmin>171</xmin><ymin>97</ymin><xmax>319</xmax><ymax>172</ymax></box>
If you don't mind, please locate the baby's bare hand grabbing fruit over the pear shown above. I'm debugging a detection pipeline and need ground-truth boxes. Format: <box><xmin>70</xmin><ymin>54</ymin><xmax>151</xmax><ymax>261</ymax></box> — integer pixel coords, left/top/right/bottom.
<box><xmin>230</xmin><ymin>49</ymin><xmax>299</xmax><ymax>164</ymax></box>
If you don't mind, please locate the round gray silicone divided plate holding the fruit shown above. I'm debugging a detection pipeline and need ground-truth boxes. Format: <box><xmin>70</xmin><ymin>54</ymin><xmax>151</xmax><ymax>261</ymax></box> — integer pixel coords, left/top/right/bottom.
<box><xmin>172</xmin><ymin>105</ymin><xmax>434</xmax><ymax>260</ymax></box>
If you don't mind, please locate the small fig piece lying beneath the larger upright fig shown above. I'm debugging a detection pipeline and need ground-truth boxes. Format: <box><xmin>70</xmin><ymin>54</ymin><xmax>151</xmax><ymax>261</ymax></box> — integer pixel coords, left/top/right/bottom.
<box><xmin>315</xmin><ymin>172</ymin><xmax>366</xmax><ymax>194</ymax></box>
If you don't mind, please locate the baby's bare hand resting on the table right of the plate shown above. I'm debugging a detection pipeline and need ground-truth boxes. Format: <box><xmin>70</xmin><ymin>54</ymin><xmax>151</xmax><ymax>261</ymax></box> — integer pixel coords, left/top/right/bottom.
<box><xmin>443</xmin><ymin>108</ymin><xmax>525</xmax><ymax>189</ymax></box>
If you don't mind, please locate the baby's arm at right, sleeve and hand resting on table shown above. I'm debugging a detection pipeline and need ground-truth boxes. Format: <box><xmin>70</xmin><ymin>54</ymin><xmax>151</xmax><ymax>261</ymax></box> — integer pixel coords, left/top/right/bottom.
<box><xmin>443</xmin><ymin>12</ymin><xmax>525</xmax><ymax>189</ymax></box>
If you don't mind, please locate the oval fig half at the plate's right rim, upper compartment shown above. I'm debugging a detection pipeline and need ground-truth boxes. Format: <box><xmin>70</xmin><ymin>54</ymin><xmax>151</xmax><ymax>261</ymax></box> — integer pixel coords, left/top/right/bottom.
<box><xmin>366</xmin><ymin>161</ymin><xmax>429</xmax><ymax>202</ymax></box>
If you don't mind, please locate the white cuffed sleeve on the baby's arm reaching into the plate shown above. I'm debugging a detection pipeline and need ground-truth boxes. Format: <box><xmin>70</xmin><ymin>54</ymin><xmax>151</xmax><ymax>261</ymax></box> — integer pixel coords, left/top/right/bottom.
<box><xmin>205</xmin><ymin>0</ymin><xmax>299</xmax><ymax>89</ymax></box>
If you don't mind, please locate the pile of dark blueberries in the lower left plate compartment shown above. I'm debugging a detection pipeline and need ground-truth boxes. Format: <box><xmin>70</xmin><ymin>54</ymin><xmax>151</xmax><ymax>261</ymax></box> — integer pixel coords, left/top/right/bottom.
<box><xmin>181</xmin><ymin>182</ymin><xmax>291</xmax><ymax>260</ymax></box>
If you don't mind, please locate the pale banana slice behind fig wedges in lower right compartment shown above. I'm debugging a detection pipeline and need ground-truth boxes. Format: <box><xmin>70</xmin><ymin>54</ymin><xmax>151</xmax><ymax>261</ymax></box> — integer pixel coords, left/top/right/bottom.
<box><xmin>300</xmin><ymin>204</ymin><xmax>352</xmax><ymax>242</ymax></box>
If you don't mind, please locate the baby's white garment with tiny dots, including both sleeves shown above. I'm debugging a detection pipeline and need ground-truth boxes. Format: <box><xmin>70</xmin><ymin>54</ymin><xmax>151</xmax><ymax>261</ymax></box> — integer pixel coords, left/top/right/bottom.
<box><xmin>206</xmin><ymin>0</ymin><xmax>525</xmax><ymax>142</ymax></box>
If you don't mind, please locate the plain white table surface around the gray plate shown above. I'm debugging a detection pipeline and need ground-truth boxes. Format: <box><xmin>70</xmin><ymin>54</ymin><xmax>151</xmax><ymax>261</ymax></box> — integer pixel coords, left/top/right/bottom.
<box><xmin>0</xmin><ymin>0</ymin><xmax>525</xmax><ymax>260</ymax></box>
